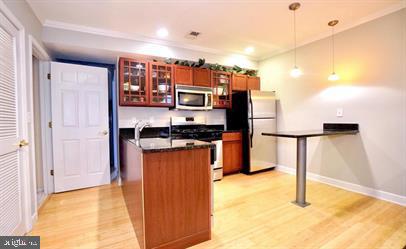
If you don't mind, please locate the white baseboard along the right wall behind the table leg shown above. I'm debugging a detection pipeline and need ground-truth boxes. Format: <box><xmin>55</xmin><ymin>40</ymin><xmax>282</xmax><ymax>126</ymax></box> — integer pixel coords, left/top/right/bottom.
<box><xmin>275</xmin><ymin>165</ymin><xmax>406</xmax><ymax>206</ymax></box>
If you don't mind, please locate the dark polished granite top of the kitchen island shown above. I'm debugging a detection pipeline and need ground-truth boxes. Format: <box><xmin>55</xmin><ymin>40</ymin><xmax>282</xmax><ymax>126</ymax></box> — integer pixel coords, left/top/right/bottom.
<box><xmin>128</xmin><ymin>138</ymin><xmax>215</xmax><ymax>153</ymax></box>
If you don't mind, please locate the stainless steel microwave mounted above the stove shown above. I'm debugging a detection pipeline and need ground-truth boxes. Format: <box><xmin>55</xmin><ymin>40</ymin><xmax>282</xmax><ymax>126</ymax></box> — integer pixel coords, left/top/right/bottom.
<box><xmin>175</xmin><ymin>85</ymin><xmax>213</xmax><ymax>110</ymax></box>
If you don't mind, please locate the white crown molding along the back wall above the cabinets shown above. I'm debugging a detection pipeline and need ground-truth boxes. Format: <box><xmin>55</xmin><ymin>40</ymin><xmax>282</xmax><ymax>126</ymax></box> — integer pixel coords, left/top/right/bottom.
<box><xmin>43</xmin><ymin>20</ymin><xmax>258</xmax><ymax>62</ymax></box>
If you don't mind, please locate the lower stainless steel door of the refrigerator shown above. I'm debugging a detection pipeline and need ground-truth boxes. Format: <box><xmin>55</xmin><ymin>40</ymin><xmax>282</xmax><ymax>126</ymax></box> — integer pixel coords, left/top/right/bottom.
<box><xmin>250</xmin><ymin>119</ymin><xmax>277</xmax><ymax>172</ymax></box>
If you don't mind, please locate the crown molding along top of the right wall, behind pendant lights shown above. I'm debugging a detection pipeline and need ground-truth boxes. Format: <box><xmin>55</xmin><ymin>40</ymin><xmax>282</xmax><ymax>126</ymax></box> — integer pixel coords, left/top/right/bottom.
<box><xmin>259</xmin><ymin>0</ymin><xmax>406</xmax><ymax>62</ymax></box>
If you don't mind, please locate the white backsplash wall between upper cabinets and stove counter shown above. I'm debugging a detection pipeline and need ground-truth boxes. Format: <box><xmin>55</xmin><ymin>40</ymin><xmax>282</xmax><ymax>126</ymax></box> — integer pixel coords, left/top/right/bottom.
<box><xmin>118</xmin><ymin>106</ymin><xmax>226</xmax><ymax>128</ymax></box>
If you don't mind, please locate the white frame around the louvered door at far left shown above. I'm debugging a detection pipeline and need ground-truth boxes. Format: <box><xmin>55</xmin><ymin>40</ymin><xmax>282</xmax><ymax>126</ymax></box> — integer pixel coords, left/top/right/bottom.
<box><xmin>0</xmin><ymin>1</ymin><xmax>33</xmax><ymax>235</ymax></box>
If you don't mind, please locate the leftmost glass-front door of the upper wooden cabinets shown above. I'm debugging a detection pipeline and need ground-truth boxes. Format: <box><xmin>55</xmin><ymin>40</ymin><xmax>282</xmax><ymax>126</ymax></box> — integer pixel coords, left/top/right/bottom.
<box><xmin>120</xmin><ymin>58</ymin><xmax>149</xmax><ymax>106</ymax></box>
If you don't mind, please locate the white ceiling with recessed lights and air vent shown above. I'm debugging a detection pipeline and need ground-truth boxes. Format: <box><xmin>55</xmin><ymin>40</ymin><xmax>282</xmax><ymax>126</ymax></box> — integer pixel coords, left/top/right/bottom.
<box><xmin>28</xmin><ymin>0</ymin><xmax>404</xmax><ymax>59</ymax></box>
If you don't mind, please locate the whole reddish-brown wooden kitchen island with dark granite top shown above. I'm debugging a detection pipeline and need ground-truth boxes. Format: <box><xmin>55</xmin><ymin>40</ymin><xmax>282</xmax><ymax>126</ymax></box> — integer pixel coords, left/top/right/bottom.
<box><xmin>120</xmin><ymin>138</ymin><xmax>213</xmax><ymax>248</ymax></box>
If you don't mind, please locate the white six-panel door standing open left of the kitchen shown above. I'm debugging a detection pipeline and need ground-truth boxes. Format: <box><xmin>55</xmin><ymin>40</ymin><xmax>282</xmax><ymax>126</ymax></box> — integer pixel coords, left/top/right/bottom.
<box><xmin>51</xmin><ymin>62</ymin><xmax>110</xmax><ymax>192</ymax></box>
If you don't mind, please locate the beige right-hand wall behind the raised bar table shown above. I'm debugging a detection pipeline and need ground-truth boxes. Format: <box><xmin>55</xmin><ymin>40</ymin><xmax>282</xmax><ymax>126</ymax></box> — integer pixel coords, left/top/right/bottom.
<box><xmin>259</xmin><ymin>9</ymin><xmax>406</xmax><ymax>196</ymax></box>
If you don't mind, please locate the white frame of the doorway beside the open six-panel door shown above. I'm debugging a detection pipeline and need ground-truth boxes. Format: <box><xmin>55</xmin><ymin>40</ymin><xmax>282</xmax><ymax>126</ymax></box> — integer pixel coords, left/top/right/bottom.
<box><xmin>26</xmin><ymin>35</ymin><xmax>52</xmax><ymax>223</ymax></box>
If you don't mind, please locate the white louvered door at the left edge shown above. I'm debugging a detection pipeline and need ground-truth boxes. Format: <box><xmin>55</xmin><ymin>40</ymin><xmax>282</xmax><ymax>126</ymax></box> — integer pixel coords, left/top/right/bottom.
<box><xmin>0</xmin><ymin>12</ymin><xmax>26</xmax><ymax>236</ymax></box>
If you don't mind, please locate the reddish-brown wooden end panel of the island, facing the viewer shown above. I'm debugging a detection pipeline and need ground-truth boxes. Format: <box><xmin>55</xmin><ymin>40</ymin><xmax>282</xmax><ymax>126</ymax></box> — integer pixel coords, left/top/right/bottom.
<box><xmin>143</xmin><ymin>149</ymin><xmax>211</xmax><ymax>248</ymax></box>
